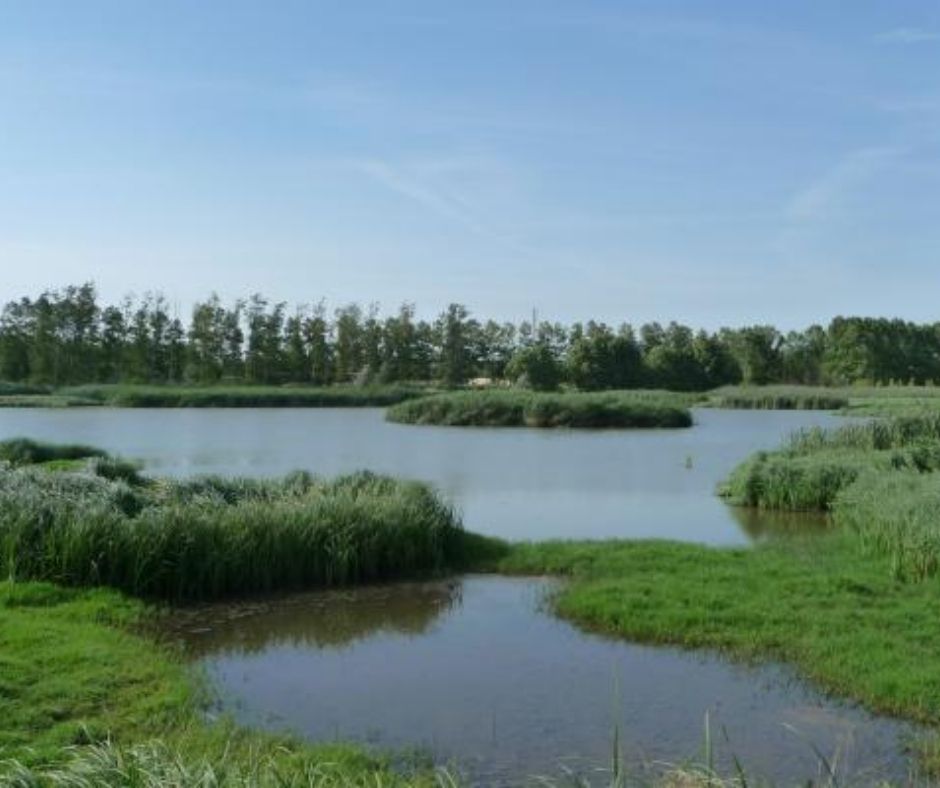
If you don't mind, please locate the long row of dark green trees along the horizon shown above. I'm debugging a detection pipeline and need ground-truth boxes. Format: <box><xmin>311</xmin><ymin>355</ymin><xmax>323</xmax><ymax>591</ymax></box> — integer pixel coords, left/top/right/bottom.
<box><xmin>0</xmin><ymin>284</ymin><xmax>940</xmax><ymax>390</ymax></box>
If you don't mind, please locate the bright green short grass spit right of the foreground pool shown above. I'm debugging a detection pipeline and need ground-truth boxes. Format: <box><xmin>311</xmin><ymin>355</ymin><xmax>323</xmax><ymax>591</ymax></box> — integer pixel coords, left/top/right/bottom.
<box><xmin>498</xmin><ymin>531</ymin><xmax>940</xmax><ymax>723</ymax></box>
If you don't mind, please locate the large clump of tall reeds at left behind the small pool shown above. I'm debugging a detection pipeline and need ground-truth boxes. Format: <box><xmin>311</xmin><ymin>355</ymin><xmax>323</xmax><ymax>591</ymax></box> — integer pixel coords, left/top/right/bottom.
<box><xmin>0</xmin><ymin>468</ymin><xmax>470</xmax><ymax>600</ymax></box>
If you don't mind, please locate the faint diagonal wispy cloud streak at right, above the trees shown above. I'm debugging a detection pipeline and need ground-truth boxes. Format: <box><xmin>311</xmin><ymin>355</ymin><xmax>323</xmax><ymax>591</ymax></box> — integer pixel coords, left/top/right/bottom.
<box><xmin>786</xmin><ymin>146</ymin><xmax>904</xmax><ymax>221</ymax></box>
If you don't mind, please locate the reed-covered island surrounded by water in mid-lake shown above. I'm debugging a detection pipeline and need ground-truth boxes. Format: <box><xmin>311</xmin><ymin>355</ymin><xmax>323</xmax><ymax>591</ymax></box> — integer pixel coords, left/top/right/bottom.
<box><xmin>387</xmin><ymin>391</ymin><xmax>692</xmax><ymax>429</ymax></box>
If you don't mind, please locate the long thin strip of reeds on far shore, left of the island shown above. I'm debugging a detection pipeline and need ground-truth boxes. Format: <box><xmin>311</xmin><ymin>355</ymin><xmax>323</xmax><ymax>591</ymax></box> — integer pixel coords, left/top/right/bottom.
<box><xmin>57</xmin><ymin>384</ymin><xmax>426</xmax><ymax>408</ymax></box>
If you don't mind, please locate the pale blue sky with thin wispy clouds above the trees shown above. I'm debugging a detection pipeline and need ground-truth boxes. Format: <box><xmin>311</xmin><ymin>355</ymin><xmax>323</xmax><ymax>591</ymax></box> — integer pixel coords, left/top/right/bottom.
<box><xmin>0</xmin><ymin>0</ymin><xmax>940</xmax><ymax>328</ymax></box>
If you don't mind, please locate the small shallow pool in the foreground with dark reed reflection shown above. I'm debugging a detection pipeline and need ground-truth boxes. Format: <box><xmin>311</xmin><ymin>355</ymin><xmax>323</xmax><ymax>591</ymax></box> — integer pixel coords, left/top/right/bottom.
<box><xmin>167</xmin><ymin>576</ymin><xmax>911</xmax><ymax>785</ymax></box>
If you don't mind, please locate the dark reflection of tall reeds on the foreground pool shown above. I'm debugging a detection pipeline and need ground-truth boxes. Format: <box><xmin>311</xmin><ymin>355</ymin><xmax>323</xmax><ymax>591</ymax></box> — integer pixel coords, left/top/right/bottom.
<box><xmin>163</xmin><ymin>579</ymin><xmax>463</xmax><ymax>657</ymax></box>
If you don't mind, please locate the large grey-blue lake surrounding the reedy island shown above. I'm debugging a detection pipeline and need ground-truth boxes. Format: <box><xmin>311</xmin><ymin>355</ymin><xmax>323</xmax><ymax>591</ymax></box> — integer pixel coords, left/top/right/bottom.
<box><xmin>0</xmin><ymin>408</ymin><xmax>845</xmax><ymax>544</ymax></box>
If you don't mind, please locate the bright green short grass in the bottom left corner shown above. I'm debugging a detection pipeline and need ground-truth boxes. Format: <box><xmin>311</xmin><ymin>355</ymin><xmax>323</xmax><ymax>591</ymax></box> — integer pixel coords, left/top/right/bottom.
<box><xmin>0</xmin><ymin>582</ymin><xmax>450</xmax><ymax>786</ymax></box>
